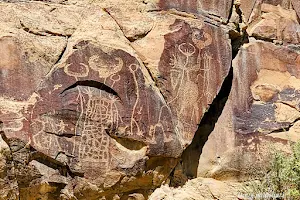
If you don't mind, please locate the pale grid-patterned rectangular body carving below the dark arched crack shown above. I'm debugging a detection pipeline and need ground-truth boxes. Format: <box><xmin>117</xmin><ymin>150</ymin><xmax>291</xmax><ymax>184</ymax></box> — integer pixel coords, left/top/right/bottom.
<box><xmin>79</xmin><ymin>89</ymin><xmax>119</xmax><ymax>169</ymax></box>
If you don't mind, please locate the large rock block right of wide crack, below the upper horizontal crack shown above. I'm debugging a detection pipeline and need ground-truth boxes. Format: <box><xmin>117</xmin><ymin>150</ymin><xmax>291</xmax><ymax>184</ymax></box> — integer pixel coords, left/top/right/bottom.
<box><xmin>198</xmin><ymin>41</ymin><xmax>300</xmax><ymax>180</ymax></box>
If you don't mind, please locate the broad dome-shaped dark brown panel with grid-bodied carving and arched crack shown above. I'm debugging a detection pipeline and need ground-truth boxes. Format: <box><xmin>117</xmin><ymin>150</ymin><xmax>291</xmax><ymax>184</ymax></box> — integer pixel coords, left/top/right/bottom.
<box><xmin>24</xmin><ymin>41</ymin><xmax>180</xmax><ymax>177</ymax></box>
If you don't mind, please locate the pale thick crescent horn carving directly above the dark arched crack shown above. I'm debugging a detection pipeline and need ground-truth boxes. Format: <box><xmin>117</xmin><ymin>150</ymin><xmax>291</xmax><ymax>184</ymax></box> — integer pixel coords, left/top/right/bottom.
<box><xmin>89</xmin><ymin>55</ymin><xmax>124</xmax><ymax>78</ymax></box>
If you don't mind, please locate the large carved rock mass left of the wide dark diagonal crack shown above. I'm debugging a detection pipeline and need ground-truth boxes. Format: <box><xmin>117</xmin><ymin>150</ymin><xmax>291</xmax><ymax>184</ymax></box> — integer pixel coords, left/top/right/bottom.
<box><xmin>0</xmin><ymin>1</ymin><xmax>232</xmax><ymax>199</ymax></box>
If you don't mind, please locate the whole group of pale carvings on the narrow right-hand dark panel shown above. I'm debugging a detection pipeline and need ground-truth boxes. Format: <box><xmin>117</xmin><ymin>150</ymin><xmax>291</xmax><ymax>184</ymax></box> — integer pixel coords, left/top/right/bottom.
<box><xmin>156</xmin><ymin>28</ymin><xmax>214</xmax><ymax>141</ymax></box>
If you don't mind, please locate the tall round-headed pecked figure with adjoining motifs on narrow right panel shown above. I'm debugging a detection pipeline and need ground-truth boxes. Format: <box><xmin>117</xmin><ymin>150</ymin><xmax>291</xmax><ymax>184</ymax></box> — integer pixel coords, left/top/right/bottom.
<box><xmin>157</xmin><ymin>29</ymin><xmax>212</xmax><ymax>140</ymax></box>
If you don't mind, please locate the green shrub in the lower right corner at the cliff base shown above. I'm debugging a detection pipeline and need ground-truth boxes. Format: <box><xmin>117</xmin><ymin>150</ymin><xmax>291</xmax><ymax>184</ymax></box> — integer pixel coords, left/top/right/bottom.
<box><xmin>241</xmin><ymin>141</ymin><xmax>300</xmax><ymax>200</ymax></box>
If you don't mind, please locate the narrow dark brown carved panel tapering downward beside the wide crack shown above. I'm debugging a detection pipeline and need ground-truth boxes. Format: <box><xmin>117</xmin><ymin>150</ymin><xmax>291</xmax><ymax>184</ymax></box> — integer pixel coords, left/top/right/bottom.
<box><xmin>158</xmin><ymin>19</ymin><xmax>230</xmax><ymax>144</ymax></box>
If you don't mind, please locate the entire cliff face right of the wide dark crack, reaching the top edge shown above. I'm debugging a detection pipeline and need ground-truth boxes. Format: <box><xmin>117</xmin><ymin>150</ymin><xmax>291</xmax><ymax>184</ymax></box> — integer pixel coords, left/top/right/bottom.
<box><xmin>198</xmin><ymin>1</ymin><xmax>300</xmax><ymax>180</ymax></box>
